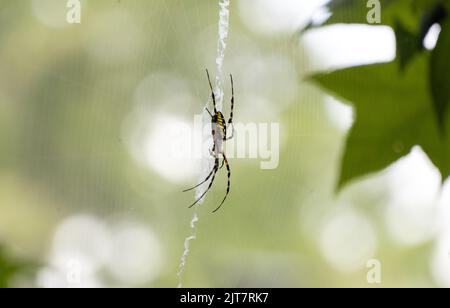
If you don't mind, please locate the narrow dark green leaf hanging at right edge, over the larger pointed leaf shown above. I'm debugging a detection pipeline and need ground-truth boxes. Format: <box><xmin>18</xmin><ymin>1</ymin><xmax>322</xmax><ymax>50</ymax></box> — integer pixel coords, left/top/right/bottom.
<box><xmin>430</xmin><ymin>21</ymin><xmax>450</xmax><ymax>128</ymax></box>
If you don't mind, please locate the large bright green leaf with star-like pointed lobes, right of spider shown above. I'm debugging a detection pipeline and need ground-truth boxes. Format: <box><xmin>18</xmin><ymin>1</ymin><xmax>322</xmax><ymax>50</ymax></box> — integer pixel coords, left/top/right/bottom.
<box><xmin>313</xmin><ymin>53</ymin><xmax>450</xmax><ymax>188</ymax></box>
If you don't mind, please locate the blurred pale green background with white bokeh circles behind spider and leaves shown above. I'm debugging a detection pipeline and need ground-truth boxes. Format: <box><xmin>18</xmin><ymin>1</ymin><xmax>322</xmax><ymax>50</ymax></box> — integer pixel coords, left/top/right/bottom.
<box><xmin>0</xmin><ymin>0</ymin><xmax>450</xmax><ymax>287</ymax></box>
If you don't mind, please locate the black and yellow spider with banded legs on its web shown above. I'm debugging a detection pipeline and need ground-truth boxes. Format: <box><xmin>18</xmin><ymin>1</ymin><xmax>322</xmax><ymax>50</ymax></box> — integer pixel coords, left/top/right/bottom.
<box><xmin>183</xmin><ymin>70</ymin><xmax>234</xmax><ymax>213</ymax></box>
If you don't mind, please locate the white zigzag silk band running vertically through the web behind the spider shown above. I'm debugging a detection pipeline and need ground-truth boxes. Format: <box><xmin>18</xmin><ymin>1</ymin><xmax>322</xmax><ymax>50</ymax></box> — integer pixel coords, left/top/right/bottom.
<box><xmin>177</xmin><ymin>0</ymin><xmax>230</xmax><ymax>288</ymax></box>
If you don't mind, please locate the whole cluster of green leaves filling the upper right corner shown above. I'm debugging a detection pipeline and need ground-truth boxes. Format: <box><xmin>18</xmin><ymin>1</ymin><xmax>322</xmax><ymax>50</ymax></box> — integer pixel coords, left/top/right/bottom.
<box><xmin>308</xmin><ymin>0</ymin><xmax>450</xmax><ymax>187</ymax></box>
